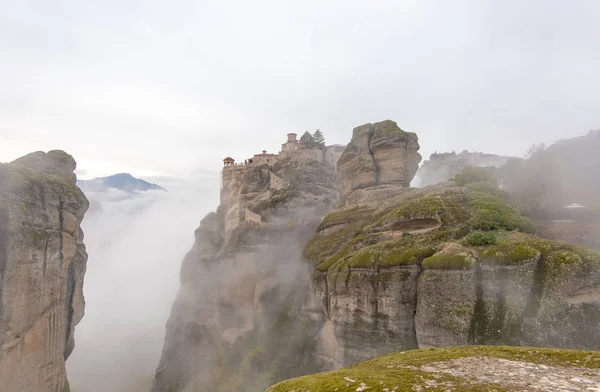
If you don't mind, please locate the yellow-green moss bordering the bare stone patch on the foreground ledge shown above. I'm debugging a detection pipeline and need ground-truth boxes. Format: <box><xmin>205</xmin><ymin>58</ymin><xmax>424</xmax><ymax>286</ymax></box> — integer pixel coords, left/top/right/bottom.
<box><xmin>267</xmin><ymin>346</ymin><xmax>600</xmax><ymax>392</ymax></box>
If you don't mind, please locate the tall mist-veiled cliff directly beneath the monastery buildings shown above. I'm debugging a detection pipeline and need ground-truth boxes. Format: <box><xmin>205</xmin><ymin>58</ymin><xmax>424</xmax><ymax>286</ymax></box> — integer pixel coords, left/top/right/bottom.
<box><xmin>153</xmin><ymin>157</ymin><xmax>341</xmax><ymax>392</ymax></box>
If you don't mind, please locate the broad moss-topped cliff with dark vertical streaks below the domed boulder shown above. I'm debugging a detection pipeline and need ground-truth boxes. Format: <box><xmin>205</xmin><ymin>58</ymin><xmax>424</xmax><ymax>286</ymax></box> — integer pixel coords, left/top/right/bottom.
<box><xmin>304</xmin><ymin>128</ymin><xmax>600</xmax><ymax>365</ymax></box>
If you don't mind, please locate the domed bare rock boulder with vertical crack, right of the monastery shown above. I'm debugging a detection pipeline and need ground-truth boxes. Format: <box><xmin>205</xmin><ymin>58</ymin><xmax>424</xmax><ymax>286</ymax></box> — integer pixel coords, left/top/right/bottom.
<box><xmin>337</xmin><ymin>120</ymin><xmax>421</xmax><ymax>197</ymax></box>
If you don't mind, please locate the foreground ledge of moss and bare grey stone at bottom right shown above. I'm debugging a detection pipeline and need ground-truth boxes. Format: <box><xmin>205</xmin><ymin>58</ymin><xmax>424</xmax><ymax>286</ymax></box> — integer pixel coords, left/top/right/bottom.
<box><xmin>267</xmin><ymin>346</ymin><xmax>600</xmax><ymax>392</ymax></box>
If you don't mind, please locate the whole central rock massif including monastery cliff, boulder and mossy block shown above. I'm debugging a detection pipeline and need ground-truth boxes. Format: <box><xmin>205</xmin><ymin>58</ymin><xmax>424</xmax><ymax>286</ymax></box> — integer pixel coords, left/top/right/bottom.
<box><xmin>153</xmin><ymin>121</ymin><xmax>600</xmax><ymax>392</ymax></box>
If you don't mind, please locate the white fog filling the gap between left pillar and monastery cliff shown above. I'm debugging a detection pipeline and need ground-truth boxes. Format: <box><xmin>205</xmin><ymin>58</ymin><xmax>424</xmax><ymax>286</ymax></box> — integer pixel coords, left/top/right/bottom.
<box><xmin>67</xmin><ymin>173</ymin><xmax>219</xmax><ymax>392</ymax></box>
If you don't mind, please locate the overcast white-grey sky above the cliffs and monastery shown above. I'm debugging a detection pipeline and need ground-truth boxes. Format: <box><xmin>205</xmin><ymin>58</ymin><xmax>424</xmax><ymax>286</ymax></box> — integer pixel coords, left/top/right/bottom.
<box><xmin>0</xmin><ymin>0</ymin><xmax>600</xmax><ymax>176</ymax></box>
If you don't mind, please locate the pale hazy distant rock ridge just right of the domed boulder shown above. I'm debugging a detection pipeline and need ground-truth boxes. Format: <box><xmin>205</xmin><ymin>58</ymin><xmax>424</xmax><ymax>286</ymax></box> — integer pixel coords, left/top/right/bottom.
<box><xmin>414</xmin><ymin>150</ymin><xmax>519</xmax><ymax>187</ymax></box>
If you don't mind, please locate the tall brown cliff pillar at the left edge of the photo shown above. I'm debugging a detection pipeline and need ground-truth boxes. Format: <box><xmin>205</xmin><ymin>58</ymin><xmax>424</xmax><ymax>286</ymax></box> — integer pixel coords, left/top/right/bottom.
<box><xmin>0</xmin><ymin>151</ymin><xmax>88</xmax><ymax>392</ymax></box>
